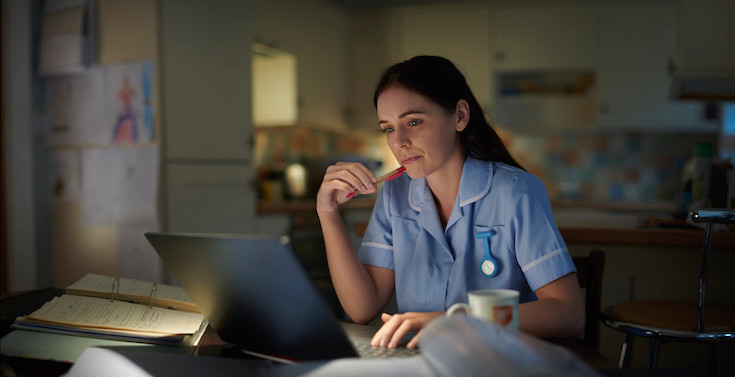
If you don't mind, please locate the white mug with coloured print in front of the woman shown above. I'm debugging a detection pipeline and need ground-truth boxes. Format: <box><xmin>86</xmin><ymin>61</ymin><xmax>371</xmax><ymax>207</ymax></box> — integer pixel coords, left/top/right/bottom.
<box><xmin>447</xmin><ymin>289</ymin><xmax>518</xmax><ymax>331</ymax></box>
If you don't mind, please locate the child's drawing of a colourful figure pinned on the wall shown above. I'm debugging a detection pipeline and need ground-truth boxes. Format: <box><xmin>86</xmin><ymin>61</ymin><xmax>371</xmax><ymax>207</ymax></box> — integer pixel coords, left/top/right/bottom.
<box><xmin>46</xmin><ymin>61</ymin><xmax>155</xmax><ymax>146</ymax></box>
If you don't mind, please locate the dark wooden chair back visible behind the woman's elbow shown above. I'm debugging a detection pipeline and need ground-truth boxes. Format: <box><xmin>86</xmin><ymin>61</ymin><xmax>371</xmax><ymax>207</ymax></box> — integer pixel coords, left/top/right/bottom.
<box><xmin>572</xmin><ymin>250</ymin><xmax>605</xmax><ymax>351</ymax></box>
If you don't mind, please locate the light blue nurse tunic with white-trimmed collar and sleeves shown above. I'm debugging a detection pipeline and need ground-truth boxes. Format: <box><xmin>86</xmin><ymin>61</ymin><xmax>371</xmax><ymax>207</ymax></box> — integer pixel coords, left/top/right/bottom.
<box><xmin>358</xmin><ymin>157</ymin><xmax>576</xmax><ymax>313</ymax></box>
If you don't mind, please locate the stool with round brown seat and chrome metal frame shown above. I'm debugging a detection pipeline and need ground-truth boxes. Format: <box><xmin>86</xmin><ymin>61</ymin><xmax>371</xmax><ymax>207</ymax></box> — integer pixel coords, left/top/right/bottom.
<box><xmin>602</xmin><ymin>209</ymin><xmax>735</xmax><ymax>371</ymax></box>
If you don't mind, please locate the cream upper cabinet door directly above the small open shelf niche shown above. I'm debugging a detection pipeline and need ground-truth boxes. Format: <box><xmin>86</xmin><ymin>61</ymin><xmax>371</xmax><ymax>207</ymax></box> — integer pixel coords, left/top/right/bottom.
<box><xmin>495</xmin><ymin>4</ymin><xmax>596</xmax><ymax>71</ymax></box>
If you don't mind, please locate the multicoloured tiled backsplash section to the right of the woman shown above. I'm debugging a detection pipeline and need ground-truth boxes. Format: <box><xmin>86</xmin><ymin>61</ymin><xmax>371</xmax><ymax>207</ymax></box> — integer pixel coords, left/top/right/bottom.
<box><xmin>508</xmin><ymin>133</ymin><xmax>717</xmax><ymax>204</ymax></box>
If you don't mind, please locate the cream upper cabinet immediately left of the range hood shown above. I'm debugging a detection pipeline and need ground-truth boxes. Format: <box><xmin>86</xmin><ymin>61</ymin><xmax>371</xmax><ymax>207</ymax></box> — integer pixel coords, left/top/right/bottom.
<box><xmin>597</xmin><ymin>1</ymin><xmax>714</xmax><ymax>131</ymax></box>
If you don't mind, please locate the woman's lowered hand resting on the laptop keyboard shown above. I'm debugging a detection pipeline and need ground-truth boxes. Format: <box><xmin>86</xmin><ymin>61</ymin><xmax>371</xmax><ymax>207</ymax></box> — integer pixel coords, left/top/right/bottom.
<box><xmin>370</xmin><ymin>312</ymin><xmax>445</xmax><ymax>348</ymax></box>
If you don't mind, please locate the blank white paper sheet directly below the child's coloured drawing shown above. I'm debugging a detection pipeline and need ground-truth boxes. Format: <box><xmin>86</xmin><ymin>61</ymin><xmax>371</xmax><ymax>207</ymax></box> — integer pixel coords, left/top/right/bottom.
<box><xmin>82</xmin><ymin>146</ymin><xmax>159</xmax><ymax>225</ymax></box>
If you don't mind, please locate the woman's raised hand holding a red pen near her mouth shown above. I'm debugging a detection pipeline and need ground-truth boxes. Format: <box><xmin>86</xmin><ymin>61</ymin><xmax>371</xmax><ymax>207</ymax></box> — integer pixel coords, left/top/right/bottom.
<box><xmin>316</xmin><ymin>162</ymin><xmax>375</xmax><ymax>214</ymax></box>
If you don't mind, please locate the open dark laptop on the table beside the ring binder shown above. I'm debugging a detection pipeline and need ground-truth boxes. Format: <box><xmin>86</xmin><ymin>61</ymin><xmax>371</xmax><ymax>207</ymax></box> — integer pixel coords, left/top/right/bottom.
<box><xmin>145</xmin><ymin>232</ymin><xmax>416</xmax><ymax>360</ymax></box>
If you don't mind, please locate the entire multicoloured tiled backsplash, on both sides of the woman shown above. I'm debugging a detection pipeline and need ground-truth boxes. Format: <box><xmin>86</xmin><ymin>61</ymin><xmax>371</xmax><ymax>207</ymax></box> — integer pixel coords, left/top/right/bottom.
<box><xmin>255</xmin><ymin>127</ymin><xmax>717</xmax><ymax>204</ymax></box>
